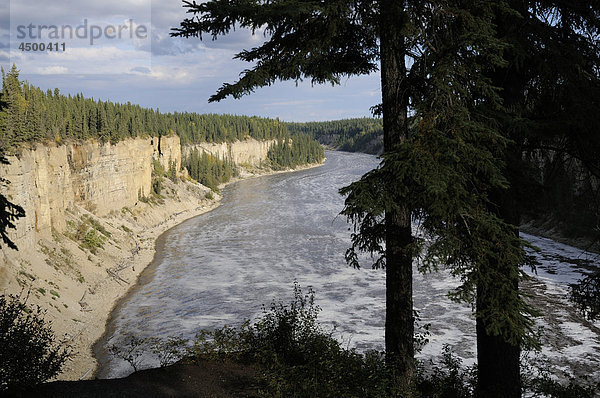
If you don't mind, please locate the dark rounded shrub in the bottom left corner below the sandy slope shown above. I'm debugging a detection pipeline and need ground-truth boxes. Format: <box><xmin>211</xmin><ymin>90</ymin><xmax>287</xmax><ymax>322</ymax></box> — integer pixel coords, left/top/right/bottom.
<box><xmin>0</xmin><ymin>295</ymin><xmax>69</xmax><ymax>392</ymax></box>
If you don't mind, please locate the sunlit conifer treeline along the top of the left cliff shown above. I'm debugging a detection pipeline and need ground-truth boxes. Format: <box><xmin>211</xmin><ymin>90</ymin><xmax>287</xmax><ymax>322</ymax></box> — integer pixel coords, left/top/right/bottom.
<box><xmin>0</xmin><ymin>66</ymin><xmax>289</xmax><ymax>149</ymax></box>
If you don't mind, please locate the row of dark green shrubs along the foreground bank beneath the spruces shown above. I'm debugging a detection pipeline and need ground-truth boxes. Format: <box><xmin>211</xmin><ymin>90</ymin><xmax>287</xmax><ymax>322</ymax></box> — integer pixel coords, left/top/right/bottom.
<box><xmin>111</xmin><ymin>283</ymin><xmax>596</xmax><ymax>398</ymax></box>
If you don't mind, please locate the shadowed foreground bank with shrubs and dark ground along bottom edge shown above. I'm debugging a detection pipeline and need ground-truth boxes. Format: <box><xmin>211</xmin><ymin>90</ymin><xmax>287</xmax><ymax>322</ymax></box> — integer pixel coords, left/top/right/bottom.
<box><xmin>21</xmin><ymin>284</ymin><xmax>595</xmax><ymax>398</ymax></box>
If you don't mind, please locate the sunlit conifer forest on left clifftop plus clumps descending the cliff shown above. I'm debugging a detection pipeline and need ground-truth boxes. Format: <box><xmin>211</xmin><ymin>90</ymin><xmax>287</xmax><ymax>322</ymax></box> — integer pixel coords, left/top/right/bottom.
<box><xmin>0</xmin><ymin>65</ymin><xmax>324</xmax><ymax>190</ymax></box>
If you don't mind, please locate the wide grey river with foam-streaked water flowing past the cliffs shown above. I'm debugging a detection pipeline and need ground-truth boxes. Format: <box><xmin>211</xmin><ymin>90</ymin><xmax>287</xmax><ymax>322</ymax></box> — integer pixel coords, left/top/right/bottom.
<box><xmin>94</xmin><ymin>152</ymin><xmax>600</xmax><ymax>379</ymax></box>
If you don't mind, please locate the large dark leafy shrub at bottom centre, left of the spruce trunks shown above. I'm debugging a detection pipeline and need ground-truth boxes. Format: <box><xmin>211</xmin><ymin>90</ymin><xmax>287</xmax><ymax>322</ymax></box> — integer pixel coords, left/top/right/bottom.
<box><xmin>192</xmin><ymin>284</ymin><xmax>398</xmax><ymax>397</ymax></box>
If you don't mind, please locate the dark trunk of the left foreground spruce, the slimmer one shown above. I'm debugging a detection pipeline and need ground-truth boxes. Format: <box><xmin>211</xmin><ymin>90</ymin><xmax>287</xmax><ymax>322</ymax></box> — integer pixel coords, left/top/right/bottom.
<box><xmin>380</xmin><ymin>0</ymin><xmax>415</xmax><ymax>386</ymax></box>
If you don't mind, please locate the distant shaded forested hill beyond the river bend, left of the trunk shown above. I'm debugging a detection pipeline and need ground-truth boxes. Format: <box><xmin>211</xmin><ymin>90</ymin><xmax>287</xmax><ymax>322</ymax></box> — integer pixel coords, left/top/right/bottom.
<box><xmin>286</xmin><ymin>118</ymin><xmax>383</xmax><ymax>154</ymax></box>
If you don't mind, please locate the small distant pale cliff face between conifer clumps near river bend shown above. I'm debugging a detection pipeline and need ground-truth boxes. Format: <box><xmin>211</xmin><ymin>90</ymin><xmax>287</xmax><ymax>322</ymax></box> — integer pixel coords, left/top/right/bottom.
<box><xmin>183</xmin><ymin>139</ymin><xmax>277</xmax><ymax>166</ymax></box>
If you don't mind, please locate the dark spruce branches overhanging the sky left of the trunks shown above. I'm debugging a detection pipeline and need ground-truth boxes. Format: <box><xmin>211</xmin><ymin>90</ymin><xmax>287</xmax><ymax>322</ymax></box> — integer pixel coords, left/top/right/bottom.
<box><xmin>173</xmin><ymin>0</ymin><xmax>378</xmax><ymax>101</ymax></box>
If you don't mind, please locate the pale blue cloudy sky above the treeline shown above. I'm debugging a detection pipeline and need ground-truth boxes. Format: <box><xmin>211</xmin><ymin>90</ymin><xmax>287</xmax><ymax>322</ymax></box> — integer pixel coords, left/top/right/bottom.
<box><xmin>0</xmin><ymin>0</ymin><xmax>381</xmax><ymax>121</ymax></box>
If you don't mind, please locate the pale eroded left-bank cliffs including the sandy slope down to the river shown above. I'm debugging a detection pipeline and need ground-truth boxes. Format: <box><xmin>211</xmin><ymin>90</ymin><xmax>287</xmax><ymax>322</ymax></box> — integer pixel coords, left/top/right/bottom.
<box><xmin>0</xmin><ymin>135</ymin><xmax>288</xmax><ymax>380</ymax></box>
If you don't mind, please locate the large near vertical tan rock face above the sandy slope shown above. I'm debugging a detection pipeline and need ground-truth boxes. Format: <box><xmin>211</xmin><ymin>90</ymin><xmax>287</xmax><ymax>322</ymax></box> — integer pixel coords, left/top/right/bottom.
<box><xmin>0</xmin><ymin>136</ymin><xmax>181</xmax><ymax>247</ymax></box>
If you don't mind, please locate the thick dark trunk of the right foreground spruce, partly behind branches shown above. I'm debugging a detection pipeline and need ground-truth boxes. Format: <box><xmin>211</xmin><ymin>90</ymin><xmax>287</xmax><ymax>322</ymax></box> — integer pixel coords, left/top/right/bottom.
<box><xmin>476</xmin><ymin>0</ymin><xmax>528</xmax><ymax>398</ymax></box>
